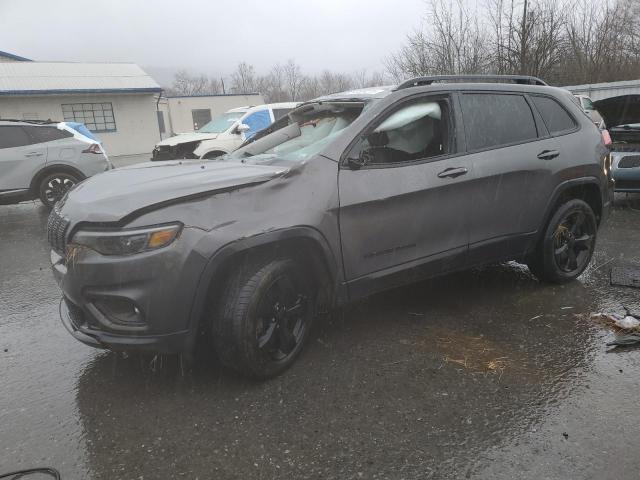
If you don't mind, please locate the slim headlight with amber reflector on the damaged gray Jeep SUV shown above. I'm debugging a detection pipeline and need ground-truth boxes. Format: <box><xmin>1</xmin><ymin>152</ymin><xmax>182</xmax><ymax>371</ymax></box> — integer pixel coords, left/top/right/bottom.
<box><xmin>71</xmin><ymin>223</ymin><xmax>182</xmax><ymax>255</ymax></box>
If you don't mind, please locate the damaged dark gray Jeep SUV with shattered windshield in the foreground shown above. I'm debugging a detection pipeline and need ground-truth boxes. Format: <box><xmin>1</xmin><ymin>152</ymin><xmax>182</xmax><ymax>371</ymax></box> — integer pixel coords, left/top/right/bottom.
<box><xmin>48</xmin><ymin>76</ymin><xmax>612</xmax><ymax>378</ymax></box>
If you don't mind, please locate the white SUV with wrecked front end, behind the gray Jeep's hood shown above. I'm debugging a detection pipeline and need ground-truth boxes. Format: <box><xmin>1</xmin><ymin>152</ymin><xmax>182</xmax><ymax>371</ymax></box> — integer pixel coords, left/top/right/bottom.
<box><xmin>152</xmin><ymin>102</ymin><xmax>299</xmax><ymax>160</ymax></box>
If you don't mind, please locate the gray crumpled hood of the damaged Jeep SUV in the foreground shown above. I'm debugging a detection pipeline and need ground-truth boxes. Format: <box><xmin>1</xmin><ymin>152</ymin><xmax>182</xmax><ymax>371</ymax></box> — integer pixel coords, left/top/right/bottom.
<box><xmin>59</xmin><ymin>160</ymin><xmax>289</xmax><ymax>223</ymax></box>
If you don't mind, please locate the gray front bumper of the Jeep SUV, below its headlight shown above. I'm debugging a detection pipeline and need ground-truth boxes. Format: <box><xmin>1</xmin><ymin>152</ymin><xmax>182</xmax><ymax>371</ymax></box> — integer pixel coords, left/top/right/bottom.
<box><xmin>51</xmin><ymin>229</ymin><xmax>206</xmax><ymax>353</ymax></box>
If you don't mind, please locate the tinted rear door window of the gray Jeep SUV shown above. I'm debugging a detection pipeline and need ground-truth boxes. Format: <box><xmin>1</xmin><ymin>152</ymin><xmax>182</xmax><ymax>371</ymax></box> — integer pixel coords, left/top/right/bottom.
<box><xmin>460</xmin><ymin>93</ymin><xmax>538</xmax><ymax>150</ymax></box>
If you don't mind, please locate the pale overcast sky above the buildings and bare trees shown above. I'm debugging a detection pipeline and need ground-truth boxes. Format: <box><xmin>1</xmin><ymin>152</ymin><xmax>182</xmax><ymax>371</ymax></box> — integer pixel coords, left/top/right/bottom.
<box><xmin>0</xmin><ymin>0</ymin><xmax>425</xmax><ymax>83</ymax></box>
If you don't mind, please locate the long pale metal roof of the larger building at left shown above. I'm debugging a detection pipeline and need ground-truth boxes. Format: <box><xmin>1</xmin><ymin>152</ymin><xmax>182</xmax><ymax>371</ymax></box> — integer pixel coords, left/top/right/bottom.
<box><xmin>0</xmin><ymin>62</ymin><xmax>162</xmax><ymax>95</ymax></box>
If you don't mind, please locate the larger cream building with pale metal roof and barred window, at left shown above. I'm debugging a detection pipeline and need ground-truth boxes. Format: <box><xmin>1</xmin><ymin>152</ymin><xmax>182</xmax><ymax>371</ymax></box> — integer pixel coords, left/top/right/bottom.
<box><xmin>0</xmin><ymin>58</ymin><xmax>161</xmax><ymax>156</ymax></box>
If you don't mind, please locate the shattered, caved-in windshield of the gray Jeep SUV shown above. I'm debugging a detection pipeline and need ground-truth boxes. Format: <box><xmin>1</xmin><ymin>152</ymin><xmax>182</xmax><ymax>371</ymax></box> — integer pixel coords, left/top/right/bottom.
<box><xmin>224</xmin><ymin>102</ymin><xmax>364</xmax><ymax>163</ymax></box>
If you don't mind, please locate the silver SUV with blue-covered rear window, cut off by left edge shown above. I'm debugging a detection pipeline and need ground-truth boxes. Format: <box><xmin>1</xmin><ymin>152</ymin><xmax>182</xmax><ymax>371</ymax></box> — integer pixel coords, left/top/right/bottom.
<box><xmin>0</xmin><ymin>119</ymin><xmax>113</xmax><ymax>208</ymax></box>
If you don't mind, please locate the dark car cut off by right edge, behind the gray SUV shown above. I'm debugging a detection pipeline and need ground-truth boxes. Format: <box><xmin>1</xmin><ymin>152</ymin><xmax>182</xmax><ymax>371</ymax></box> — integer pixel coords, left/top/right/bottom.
<box><xmin>594</xmin><ymin>95</ymin><xmax>640</xmax><ymax>193</ymax></box>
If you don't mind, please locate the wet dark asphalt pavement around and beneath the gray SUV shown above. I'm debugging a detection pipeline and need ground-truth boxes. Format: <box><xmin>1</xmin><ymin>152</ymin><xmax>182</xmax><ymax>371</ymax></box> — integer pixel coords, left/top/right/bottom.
<box><xmin>0</xmin><ymin>197</ymin><xmax>640</xmax><ymax>479</ymax></box>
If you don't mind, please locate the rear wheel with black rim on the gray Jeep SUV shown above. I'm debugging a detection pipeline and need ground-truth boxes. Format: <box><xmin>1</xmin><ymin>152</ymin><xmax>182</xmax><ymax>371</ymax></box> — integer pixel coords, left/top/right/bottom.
<box><xmin>527</xmin><ymin>199</ymin><xmax>598</xmax><ymax>283</ymax></box>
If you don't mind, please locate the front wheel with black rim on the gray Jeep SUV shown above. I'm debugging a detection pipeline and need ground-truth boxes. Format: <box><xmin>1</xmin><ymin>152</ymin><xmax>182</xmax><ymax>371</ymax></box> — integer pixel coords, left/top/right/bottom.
<box><xmin>211</xmin><ymin>259</ymin><xmax>315</xmax><ymax>379</ymax></box>
